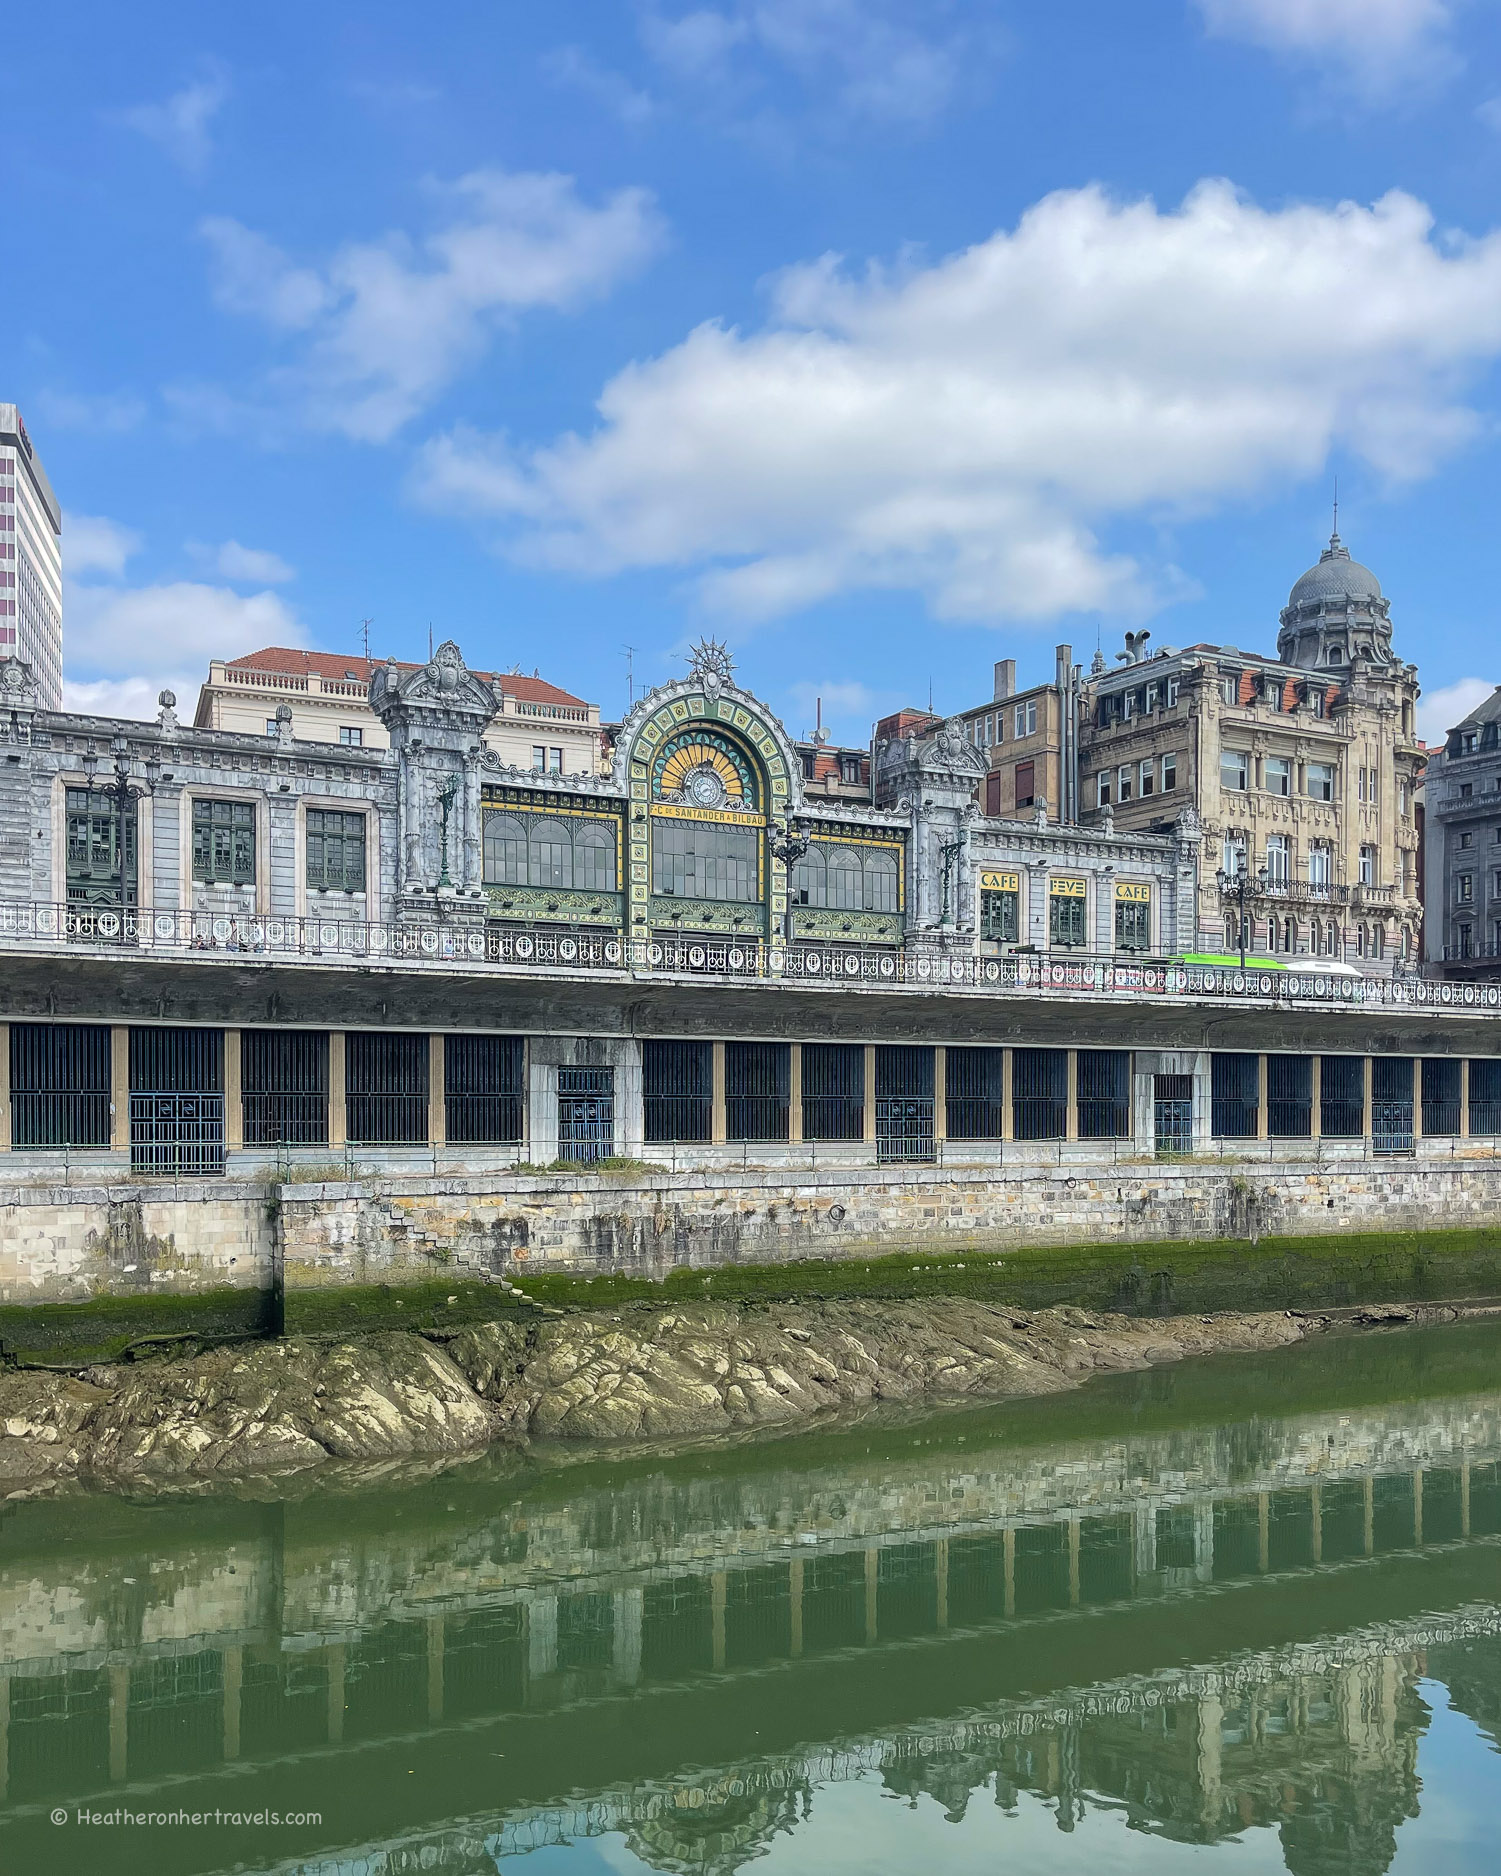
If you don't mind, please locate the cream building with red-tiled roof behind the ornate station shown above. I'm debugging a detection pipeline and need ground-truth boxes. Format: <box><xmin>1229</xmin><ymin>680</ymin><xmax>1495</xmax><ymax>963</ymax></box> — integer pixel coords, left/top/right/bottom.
<box><xmin>193</xmin><ymin>645</ymin><xmax>608</xmax><ymax>775</ymax></box>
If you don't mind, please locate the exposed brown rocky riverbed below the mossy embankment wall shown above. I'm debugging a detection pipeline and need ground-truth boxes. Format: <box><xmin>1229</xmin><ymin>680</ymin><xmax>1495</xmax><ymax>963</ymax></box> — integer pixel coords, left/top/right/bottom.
<box><xmin>0</xmin><ymin>1298</ymin><xmax>1440</xmax><ymax>1495</ymax></box>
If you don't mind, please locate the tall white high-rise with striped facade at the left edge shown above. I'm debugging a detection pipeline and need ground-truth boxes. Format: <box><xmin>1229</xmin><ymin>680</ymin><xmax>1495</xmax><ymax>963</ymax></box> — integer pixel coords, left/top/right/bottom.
<box><xmin>0</xmin><ymin>403</ymin><xmax>62</xmax><ymax>709</ymax></box>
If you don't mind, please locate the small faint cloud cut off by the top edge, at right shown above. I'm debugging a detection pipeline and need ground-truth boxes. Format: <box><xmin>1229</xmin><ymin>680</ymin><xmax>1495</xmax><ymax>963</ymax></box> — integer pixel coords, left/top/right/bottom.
<box><xmin>1199</xmin><ymin>0</ymin><xmax>1452</xmax><ymax>94</ymax></box>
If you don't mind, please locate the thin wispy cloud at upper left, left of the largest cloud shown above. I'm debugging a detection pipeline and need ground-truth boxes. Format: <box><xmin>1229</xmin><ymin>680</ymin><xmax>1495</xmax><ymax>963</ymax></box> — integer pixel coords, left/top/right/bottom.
<box><xmin>203</xmin><ymin>169</ymin><xmax>662</xmax><ymax>443</ymax></box>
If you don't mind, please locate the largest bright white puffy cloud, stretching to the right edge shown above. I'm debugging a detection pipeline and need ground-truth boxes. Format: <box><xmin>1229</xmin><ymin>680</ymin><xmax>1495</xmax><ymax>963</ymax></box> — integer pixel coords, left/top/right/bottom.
<box><xmin>415</xmin><ymin>182</ymin><xmax>1501</xmax><ymax>621</ymax></box>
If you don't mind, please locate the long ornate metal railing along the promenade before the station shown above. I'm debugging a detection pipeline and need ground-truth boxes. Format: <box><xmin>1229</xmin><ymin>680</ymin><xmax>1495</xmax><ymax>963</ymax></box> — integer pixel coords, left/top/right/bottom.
<box><xmin>0</xmin><ymin>900</ymin><xmax>1501</xmax><ymax>1011</ymax></box>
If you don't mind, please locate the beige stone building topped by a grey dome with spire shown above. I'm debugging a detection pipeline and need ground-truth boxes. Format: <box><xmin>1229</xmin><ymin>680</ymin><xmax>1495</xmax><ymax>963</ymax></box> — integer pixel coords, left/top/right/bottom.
<box><xmin>1079</xmin><ymin>535</ymin><xmax>1424</xmax><ymax>970</ymax></box>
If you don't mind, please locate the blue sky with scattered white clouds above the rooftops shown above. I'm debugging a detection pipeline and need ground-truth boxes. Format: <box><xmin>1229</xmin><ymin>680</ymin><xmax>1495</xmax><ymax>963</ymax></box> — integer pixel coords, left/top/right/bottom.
<box><xmin>0</xmin><ymin>0</ymin><xmax>1501</xmax><ymax>739</ymax></box>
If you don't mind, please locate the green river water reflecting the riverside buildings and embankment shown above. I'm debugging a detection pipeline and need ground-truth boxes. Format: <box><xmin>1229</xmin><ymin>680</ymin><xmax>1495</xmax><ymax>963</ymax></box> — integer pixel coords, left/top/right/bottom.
<box><xmin>0</xmin><ymin>1326</ymin><xmax>1501</xmax><ymax>1876</ymax></box>
